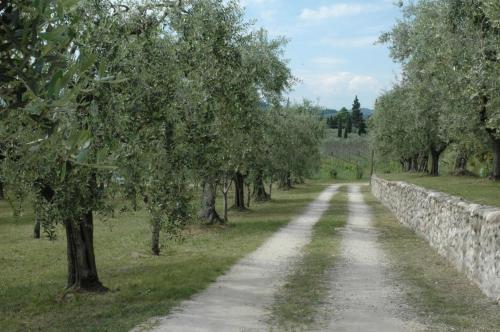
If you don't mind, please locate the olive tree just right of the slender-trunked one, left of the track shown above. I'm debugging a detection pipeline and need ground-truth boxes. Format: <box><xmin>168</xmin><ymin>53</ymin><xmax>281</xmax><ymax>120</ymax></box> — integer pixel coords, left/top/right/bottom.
<box><xmin>171</xmin><ymin>0</ymin><xmax>254</xmax><ymax>223</ymax></box>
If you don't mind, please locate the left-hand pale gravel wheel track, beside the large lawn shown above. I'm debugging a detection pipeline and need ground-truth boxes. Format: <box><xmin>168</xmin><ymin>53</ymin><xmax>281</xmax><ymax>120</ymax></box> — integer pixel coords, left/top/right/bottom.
<box><xmin>134</xmin><ymin>185</ymin><xmax>339</xmax><ymax>332</ymax></box>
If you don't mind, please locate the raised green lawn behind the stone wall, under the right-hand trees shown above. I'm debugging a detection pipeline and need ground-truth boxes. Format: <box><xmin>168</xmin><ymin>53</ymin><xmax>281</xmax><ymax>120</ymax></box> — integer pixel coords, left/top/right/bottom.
<box><xmin>377</xmin><ymin>173</ymin><xmax>500</xmax><ymax>207</ymax></box>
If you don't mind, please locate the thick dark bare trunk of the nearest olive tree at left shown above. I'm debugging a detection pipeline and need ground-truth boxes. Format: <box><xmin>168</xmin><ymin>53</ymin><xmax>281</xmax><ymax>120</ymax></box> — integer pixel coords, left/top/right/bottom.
<box><xmin>64</xmin><ymin>211</ymin><xmax>108</xmax><ymax>292</ymax></box>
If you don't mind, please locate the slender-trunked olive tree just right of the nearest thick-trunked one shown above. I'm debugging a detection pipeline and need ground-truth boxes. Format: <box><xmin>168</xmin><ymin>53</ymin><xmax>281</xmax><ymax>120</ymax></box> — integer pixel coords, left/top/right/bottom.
<box><xmin>110</xmin><ymin>2</ymin><xmax>190</xmax><ymax>255</ymax></box>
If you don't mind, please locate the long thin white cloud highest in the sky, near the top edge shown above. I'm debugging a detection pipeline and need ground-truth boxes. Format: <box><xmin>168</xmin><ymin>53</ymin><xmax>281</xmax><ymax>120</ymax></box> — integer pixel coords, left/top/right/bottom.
<box><xmin>300</xmin><ymin>3</ymin><xmax>381</xmax><ymax>21</ymax></box>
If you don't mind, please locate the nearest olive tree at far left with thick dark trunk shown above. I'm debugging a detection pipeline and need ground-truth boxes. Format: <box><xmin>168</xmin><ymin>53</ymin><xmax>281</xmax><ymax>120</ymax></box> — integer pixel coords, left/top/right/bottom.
<box><xmin>0</xmin><ymin>0</ymin><xmax>135</xmax><ymax>291</ymax></box>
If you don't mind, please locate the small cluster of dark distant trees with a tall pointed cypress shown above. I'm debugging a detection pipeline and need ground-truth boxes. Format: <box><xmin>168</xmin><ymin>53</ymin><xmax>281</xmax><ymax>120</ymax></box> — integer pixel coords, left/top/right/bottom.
<box><xmin>326</xmin><ymin>96</ymin><xmax>367</xmax><ymax>138</ymax></box>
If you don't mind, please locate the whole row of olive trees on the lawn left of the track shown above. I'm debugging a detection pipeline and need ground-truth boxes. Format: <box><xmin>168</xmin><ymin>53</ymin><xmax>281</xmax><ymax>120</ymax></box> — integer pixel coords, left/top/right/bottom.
<box><xmin>0</xmin><ymin>0</ymin><xmax>321</xmax><ymax>291</ymax></box>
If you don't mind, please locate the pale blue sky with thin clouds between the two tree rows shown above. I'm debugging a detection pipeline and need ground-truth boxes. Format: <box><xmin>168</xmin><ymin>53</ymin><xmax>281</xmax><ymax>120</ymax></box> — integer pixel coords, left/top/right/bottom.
<box><xmin>240</xmin><ymin>0</ymin><xmax>400</xmax><ymax>109</ymax></box>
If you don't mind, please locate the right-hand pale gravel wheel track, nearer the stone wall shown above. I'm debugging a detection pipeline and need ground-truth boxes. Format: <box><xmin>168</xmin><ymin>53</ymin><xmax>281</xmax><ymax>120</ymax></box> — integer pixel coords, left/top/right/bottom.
<box><xmin>325</xmin><ymin>185</ymin><xmax>425</xmax><ymax>332</ymax></box>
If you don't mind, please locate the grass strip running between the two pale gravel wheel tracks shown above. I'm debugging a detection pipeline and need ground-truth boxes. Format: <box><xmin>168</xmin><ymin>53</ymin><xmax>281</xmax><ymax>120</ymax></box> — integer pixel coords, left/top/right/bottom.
<box><xmin>270</xmin><ymin>186</ymin><xmax>347</xmax><ymax>331</ymax></box>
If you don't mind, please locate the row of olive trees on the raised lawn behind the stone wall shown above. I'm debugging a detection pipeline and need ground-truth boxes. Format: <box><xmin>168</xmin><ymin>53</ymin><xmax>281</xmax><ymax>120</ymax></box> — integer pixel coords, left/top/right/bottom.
<box><xmin>371</xmin><ymin>0</ymin><xmax>500</xmax><ymax>180</ymax></box>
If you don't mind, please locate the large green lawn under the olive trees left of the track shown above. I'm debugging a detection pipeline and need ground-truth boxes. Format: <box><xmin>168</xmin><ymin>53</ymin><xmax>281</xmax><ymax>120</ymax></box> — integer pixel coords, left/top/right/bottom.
<box><xmin>0</xmin><ymin>182</ymin><xmax>326</xmax><ymax>331</ymax></box>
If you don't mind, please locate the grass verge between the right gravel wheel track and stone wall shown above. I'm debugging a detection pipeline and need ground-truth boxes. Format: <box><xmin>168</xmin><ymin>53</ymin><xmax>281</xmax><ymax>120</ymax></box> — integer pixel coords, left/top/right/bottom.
<box><xmin>365</xmin><ymin>188</ymin><xmax>500</xmax><ymax>332</ymax></box>
